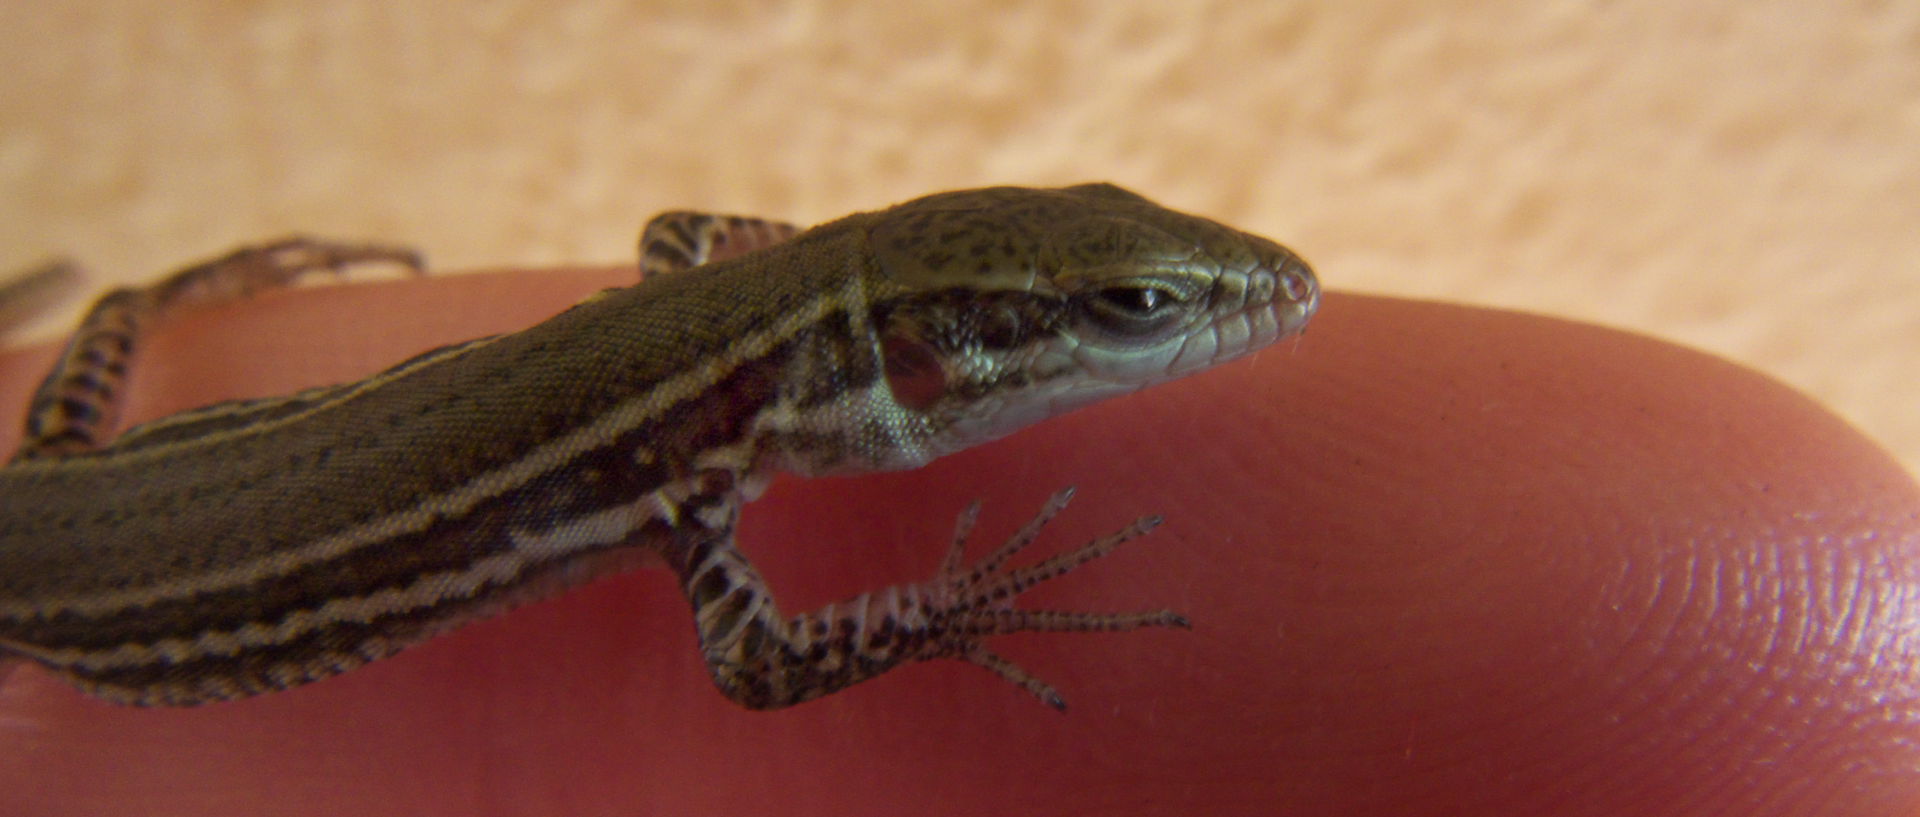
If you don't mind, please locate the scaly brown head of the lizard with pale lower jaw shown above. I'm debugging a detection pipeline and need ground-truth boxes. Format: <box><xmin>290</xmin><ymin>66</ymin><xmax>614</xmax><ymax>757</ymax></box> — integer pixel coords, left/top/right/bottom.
<box><xmin>868</xmin><ymin>184</ymin><xmax>1319</xmax><ymax>458</ymax></box>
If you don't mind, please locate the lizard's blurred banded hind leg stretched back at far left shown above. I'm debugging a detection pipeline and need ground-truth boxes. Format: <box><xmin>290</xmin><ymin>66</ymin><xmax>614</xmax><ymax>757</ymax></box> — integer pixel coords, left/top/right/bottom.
<box><xmin>13</xmin><ymin>238</ymin><xmax>422</xmax><ymax>462</ymax></box>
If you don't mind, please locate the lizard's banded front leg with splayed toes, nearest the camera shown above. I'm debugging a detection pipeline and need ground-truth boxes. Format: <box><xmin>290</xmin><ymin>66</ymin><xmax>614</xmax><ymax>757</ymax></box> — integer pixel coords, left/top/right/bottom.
<box><xmin>668</xmin><ymin>489</ymin><xmax>1188</xmax><ymax>710</ymax></box>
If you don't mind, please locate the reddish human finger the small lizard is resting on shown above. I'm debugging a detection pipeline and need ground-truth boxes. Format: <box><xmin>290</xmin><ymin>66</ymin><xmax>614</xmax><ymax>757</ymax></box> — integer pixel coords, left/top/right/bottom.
<box><xmin>0</xmin><ymin>270</ymin><xmax>1920</xmax><ymax>815</ymax></box>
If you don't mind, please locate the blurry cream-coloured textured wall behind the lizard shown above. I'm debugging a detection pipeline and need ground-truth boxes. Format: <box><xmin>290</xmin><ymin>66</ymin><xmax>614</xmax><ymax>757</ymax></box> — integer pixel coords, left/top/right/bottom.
<box><xmin>0</xmin><ymin>0</ymin><xmax>1920</xmax><ymax>468</ymax></box>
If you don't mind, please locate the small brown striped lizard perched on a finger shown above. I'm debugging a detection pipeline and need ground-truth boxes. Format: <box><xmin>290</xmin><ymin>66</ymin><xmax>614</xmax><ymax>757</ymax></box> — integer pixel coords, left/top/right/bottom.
<box><xmin>0</xmin><ymin>184</ymin><xmax>1319</xmax><ymax>710</ymax></box>
